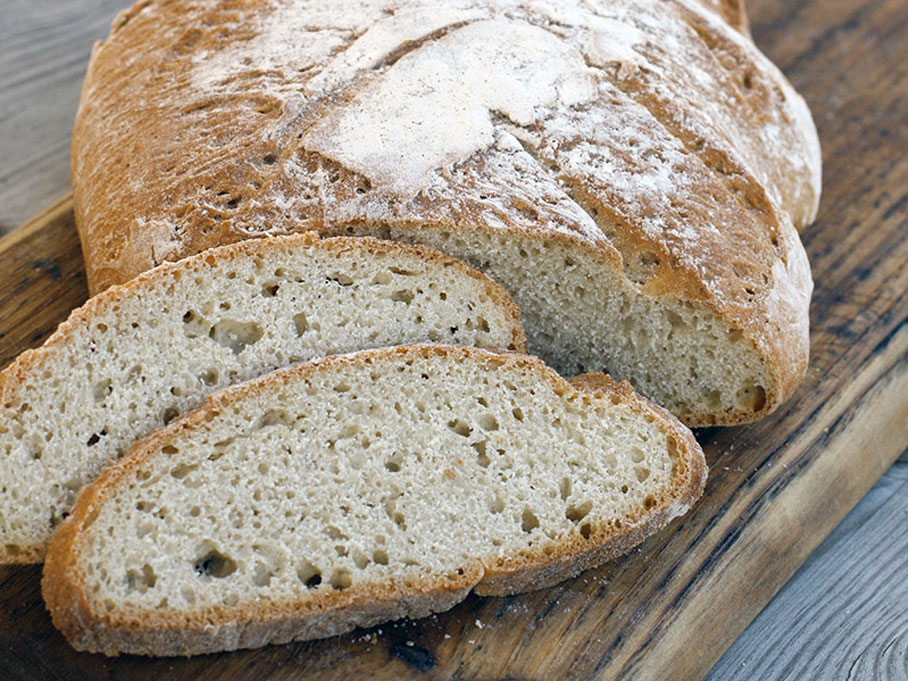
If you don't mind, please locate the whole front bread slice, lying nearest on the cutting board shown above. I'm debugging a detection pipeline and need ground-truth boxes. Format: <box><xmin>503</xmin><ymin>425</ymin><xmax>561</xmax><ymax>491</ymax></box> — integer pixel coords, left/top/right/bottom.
<box><xmin>42</xmin><ymin>345</ymin><xmax>706</xmax><ymax>655</ymax></box>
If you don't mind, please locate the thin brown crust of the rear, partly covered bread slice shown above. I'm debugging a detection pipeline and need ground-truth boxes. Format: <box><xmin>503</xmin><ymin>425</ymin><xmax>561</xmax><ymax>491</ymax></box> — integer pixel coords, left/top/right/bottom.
<box><xmin>0</xmin><ymin>232</ymin><xmax>527</xmax><ymax>564</ymax></box>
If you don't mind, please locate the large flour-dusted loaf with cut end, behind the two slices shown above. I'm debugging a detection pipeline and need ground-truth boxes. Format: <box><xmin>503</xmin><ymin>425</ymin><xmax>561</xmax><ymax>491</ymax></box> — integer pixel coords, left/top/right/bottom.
<box><xmin>72</xmin><ymin>0</ymin><xmax>820</xmax><ymax>425</ymax></box>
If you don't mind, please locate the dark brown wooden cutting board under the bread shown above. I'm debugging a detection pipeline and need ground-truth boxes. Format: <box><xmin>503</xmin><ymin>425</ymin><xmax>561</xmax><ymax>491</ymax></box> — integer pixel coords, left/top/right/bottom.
<box><xmin>0</xmin><ymin>0</ymin><xmax>908</xmax><ymax>681</ymax></box>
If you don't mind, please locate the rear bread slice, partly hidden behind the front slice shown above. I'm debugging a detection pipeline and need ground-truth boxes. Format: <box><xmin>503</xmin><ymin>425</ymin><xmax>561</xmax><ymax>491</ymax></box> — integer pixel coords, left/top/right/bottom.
<box><xmin>0</xmin><ymin>234</ymin><xmax>526</xmax><ymax>563</ymax></box>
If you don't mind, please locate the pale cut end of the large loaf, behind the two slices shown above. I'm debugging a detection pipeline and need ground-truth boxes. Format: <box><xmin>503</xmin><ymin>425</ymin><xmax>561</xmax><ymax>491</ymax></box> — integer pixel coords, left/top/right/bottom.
<box><xmin>316</xmin><ymin>225</ymin><xmax>812</xmax><ymax>427</ymax></box>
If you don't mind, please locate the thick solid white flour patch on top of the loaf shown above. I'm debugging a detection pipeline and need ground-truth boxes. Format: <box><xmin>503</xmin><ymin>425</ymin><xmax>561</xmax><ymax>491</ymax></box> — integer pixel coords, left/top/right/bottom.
<box><xmin>303</xmin><ymin>19</ymin><xmax>595</xmax><ymax>198</ymax></box>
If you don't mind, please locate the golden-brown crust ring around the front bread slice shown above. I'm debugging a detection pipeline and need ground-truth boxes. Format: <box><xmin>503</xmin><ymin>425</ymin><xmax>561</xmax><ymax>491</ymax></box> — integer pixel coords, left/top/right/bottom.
<box><xmin>41</xmin><ymin>345</ymin><xmax>706</xmax><ymax>655</ymax></box>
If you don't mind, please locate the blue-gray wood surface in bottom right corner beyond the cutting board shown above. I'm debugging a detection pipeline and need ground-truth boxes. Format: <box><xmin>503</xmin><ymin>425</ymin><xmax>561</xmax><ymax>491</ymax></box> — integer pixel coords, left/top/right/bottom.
<box><xmin>706</xmin><ymin>452</ymin><xmax>908</xmax><ymax>681</ymax></box>
